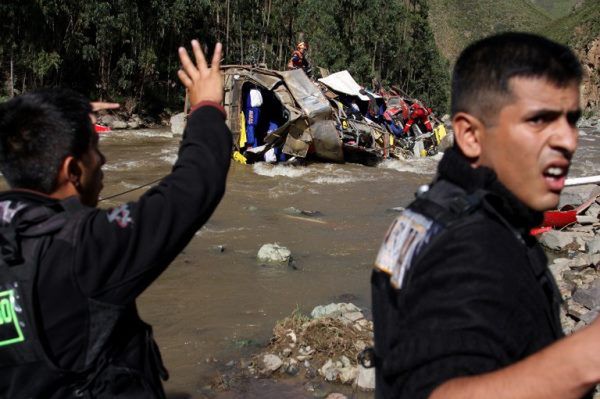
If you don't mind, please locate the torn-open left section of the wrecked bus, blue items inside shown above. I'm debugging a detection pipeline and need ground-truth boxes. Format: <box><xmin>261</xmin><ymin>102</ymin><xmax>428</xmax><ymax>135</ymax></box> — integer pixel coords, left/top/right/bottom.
<box><xmin>222</xmin><ymin>65</ymin><xmax>344</xmax><ymax>163</ymax></box>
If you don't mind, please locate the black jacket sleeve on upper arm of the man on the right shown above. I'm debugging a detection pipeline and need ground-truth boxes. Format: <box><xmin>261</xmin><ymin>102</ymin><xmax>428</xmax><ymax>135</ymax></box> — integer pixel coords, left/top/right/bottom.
<box><xmin>373</xmin><ymin>225</ymin><xmax>534</xmax><ymax>399</ymax></box>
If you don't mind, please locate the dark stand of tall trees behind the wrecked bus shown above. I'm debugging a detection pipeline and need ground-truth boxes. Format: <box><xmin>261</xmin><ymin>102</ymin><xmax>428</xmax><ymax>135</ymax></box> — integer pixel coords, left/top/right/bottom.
<box><xmin>0</xmin><ymin>0</ymin><xmax>449</xmax><ymax>114</ymax></box>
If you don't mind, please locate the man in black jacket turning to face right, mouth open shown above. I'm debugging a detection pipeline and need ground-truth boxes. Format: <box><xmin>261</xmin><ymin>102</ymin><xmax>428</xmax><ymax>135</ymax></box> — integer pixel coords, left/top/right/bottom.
<box><xmin>370</xmin><ymin>33</ymin><xmax>600</xmax><ymax>399</ymax></box>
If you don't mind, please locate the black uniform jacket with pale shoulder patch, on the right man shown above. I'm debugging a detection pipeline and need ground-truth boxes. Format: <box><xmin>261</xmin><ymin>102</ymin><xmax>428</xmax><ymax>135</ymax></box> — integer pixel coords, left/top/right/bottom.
<box><xmin>372</xmin><ymin>150</ymin><xmax>563</xmax><ymax>399</ymax></box>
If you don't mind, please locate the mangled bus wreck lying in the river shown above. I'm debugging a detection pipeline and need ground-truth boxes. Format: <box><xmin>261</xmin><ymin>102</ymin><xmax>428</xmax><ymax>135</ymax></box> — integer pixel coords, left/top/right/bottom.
<box><xmin>222</xmin><ymin>65</ymin><xmax>446</xmax><ymax>165</ymax></box>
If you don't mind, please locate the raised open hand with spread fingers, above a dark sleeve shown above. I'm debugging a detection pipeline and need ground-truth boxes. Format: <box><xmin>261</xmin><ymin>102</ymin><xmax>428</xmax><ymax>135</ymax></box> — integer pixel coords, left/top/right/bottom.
<box><xmin>177</xmin><ymin>40</ymin><xmax>223</xmax><ymax>107</ymax></box>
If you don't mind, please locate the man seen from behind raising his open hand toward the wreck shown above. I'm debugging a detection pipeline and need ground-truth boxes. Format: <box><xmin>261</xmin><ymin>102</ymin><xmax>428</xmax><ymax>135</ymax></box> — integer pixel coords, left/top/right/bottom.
<box><xmin>0</xmin><ymin>40</ymin><xmax>232</xmax><ymax>399</ymax></box>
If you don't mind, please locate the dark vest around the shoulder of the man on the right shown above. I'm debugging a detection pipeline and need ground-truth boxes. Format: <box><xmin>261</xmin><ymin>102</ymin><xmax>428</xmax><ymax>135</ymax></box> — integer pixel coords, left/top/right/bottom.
<box><xmin>359</xmin><ymin>180</ymin><xmax>564</xmax><ymax>398</ymax></box>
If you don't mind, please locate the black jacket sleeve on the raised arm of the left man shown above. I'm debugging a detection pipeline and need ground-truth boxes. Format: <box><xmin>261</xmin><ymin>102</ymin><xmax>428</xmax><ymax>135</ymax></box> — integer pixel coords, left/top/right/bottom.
<box><xmin>74</xmin><ymin>106</ymin><xmax>232</xmax><ymax>304</ymax></box>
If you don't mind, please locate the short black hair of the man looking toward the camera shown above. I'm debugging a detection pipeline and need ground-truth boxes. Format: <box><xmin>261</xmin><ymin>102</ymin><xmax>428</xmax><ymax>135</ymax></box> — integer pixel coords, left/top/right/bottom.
<box><xmin>451</xmin><ymin>32</ymin><xmax>583</xmax><ymax>123</ymax></box>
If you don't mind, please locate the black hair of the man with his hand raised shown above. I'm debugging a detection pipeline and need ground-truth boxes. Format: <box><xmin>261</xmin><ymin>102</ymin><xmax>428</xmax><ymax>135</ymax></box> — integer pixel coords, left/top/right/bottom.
<box><xmin>0</xmin><ymin>88</ymin><xmax>95</xmax><ymax>194</ymax></box>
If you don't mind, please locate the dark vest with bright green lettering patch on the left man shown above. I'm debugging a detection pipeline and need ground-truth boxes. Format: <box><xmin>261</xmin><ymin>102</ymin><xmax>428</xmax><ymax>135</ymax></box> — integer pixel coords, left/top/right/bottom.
<box><xmin>0</xmin><ymin>199</ymin><xmax>168</xmax><ymax>399</ymax></box>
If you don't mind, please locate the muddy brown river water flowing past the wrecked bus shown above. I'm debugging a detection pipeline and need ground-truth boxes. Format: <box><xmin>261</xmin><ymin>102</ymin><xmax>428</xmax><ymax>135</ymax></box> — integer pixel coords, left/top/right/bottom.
<box><xmin>3</xmin><ymin>124</ymin><xmax>600</xmax><ymax>399</ymax></box>
